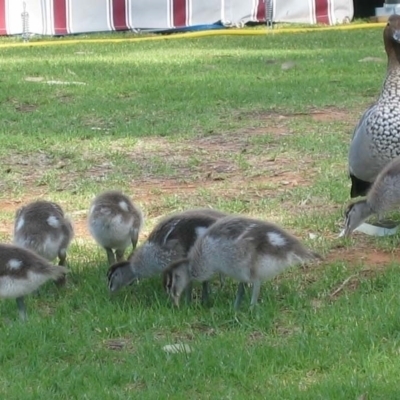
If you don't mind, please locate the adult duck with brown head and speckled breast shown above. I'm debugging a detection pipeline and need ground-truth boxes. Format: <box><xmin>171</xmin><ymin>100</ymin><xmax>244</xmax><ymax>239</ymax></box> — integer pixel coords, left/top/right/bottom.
<box><xmin>349</xmin><ymin>15</ymin><xmax>400</xmax><ymax>197</ymax></box>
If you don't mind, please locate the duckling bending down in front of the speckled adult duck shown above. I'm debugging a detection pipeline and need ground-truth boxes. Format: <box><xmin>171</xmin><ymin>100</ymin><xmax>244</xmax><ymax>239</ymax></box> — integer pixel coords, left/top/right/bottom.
<box><xmin>340</xmin><ymin>153</ymin><xmax>400</xmax><ymax>237</ymax></box>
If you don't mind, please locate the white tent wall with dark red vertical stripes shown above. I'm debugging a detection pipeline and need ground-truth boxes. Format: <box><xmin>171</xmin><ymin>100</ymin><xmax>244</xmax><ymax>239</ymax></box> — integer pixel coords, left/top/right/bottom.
<box><xmin>0</xmin><ymin>0</ymin><xmax>353</xmax><ymax>35</ymax></box>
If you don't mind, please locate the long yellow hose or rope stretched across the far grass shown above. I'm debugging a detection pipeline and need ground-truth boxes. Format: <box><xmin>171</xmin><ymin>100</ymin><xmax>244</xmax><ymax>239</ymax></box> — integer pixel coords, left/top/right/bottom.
<box><xmin>0</xmin><ymin>23</ymin><xmax>386</xmax><ymax>48</ymax></box>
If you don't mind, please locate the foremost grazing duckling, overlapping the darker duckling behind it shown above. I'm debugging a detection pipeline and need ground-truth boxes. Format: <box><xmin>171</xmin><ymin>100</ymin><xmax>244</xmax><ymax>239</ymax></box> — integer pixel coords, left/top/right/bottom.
<box><xmin>163</xmin><ymin>216</ymin><xmax>321</xmax><ymax>310</ymax></box>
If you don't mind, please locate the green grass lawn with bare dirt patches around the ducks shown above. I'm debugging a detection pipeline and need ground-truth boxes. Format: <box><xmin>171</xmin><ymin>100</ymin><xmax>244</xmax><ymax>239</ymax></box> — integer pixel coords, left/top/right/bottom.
<box><xmin>0</xmin><ymin>29</ymin><xmax>400</xmax><ymax>400</ymax></box>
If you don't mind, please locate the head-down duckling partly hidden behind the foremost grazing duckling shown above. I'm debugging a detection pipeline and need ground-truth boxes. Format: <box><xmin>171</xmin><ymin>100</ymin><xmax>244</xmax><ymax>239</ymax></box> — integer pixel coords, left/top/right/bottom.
<box><xmin>107</xmin><ymin>209</ymin><xmax>226</xmax><ymax>296</ymax></box>
